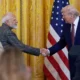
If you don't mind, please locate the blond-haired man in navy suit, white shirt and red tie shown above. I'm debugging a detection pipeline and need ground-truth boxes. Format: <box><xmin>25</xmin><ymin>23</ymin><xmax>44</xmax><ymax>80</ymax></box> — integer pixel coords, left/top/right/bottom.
<box><xmin>41</xmin><ymin>5</ymin><xmax>80</xmax><ymax>80</ymax></box>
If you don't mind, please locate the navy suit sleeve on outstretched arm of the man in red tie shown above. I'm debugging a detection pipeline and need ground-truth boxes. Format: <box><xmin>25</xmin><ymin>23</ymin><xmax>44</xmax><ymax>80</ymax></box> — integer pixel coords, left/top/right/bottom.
<box><xmin>49</xmin><ymin>28</ymin><xmax>66</xmax><ymax>55</ymax></box>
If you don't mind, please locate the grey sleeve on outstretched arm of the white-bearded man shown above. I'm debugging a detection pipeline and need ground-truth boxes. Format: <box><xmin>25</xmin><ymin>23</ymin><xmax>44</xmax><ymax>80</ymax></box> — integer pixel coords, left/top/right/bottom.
<box><xmin>6</xmin><ymin>31</ymin><xmax>40</xmax><ymax>56</ymax></box>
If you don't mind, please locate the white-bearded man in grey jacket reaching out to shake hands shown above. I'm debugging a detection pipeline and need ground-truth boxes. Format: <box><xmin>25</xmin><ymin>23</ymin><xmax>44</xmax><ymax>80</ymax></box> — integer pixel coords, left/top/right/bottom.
<box><xmin>0</xmin><ymin>13</ymin><xmax>44</xmax><ymax>56</ymax></box>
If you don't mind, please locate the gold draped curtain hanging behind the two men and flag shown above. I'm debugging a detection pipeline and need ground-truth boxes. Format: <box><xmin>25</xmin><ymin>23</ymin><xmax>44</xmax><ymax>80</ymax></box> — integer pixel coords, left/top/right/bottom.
<box><xmin>0</xmin><ymin>0</ymin><xmax>80</xmax><ymax>80</ymax></box>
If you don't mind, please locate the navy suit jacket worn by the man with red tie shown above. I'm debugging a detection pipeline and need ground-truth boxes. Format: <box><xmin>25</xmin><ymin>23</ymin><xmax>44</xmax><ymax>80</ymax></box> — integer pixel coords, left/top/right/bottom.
<box><xmin>49</xmin><ymin>17</ymin><xmax>80</xmax><ymax>55</ymax></box>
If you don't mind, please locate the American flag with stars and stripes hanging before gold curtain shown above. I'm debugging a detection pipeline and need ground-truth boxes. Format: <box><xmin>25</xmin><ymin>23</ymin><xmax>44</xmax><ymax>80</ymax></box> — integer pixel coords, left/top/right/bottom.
<box><xmin>44</xmin><ymin>0</ymin><xmax>70</xmax><ymax>80</ymax></box>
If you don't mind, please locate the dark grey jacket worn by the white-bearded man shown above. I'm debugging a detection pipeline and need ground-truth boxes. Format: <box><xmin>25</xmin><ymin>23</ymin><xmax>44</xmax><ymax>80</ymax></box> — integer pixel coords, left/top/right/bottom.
<box><xmin>0</xmin><ymin>23</ymin><xmax>40</xmax><ymax>56</ymax></box>
